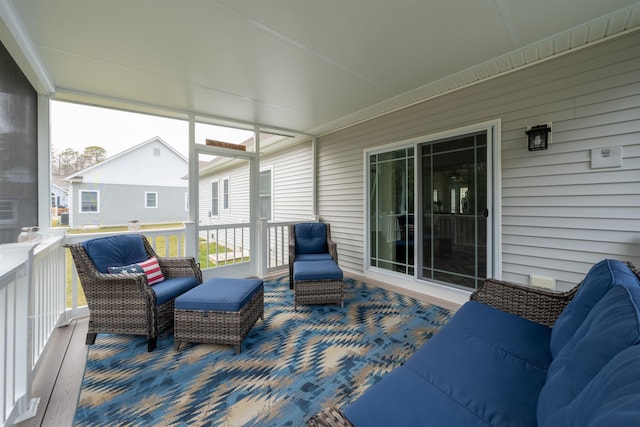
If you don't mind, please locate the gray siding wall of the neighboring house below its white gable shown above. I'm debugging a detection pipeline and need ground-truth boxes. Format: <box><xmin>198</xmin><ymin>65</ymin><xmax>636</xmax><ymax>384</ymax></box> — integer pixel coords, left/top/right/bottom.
<box><xmin>72</xmin><ymin>183</ymin><xmax>189</xmax><ymax>231</ymax></box>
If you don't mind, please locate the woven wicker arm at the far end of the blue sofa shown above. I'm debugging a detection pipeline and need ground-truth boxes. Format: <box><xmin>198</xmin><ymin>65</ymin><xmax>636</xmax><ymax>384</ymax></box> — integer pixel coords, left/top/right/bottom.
<box><xmin>470</xmin><ymin>279</ymin><xmax>579</xmax><ymax>327</ymax></box>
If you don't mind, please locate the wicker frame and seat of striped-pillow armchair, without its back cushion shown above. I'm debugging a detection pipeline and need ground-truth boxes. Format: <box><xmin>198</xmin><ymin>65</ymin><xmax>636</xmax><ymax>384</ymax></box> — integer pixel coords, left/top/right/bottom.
<box><xmin>65</xmin><ymin>235</ymin><xmax>202</xmax><ymax>351</ymax></box>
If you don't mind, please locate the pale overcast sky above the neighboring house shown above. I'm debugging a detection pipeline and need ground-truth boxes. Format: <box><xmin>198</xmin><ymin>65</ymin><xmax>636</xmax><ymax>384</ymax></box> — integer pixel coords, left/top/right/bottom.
<box><xmin>51</xmin><ymin>101</ymin><xmax>251</xmax><ymax>157</ymax></box>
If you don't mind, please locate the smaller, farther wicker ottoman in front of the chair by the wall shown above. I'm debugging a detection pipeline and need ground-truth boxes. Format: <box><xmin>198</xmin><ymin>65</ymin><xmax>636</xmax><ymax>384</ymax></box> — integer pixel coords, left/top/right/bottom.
<box><xmin>293</xmin><ymin>260</ymin><xmax>344</xmax><ymax>309</ymax></box>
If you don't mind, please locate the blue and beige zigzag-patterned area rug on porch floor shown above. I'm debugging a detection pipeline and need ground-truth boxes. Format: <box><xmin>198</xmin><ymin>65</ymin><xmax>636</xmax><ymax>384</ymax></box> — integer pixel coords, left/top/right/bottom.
<box><xmin>74</xmin><ymin>277</ymin><xmax>451</xmax><ymax>426</ymax></box>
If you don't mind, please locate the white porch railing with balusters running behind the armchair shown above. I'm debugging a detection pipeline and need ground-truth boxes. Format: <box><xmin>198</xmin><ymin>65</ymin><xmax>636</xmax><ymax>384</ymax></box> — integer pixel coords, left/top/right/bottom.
<box><xmin>0</xmin><ymin>221</ymin><xmax>298</xmax><ymax>425</ymax></box>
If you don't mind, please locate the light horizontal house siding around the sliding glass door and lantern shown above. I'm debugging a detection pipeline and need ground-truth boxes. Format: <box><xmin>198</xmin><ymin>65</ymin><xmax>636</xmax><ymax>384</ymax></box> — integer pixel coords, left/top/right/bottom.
<box><xmin>318</xmin><ymin>32</ymin><xmax>640</xmax><ymax>289</ymax></box>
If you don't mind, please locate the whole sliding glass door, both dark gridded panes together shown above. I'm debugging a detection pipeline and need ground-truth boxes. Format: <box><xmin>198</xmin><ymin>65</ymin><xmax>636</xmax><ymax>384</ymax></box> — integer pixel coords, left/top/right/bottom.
<box><xmin>368</xmin><ymin>128</ymin><xmax>492</xmax><ymax>289</ymax></box>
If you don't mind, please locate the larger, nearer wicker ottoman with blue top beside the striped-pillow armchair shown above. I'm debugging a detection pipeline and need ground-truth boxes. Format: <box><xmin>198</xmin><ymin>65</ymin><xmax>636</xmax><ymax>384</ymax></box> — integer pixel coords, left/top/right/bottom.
<box><xmin>173</xmin><ymin>278</ymin><xmax>264</xmax><ymax>353</ymax></box>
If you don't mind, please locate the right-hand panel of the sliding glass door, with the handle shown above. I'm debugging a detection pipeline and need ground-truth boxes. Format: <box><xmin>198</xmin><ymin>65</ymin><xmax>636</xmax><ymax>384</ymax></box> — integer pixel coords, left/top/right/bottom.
<box><xmin>418</xmin><ymin>132</ymin><xmax>489</xmax><ymax>289</ymax></box>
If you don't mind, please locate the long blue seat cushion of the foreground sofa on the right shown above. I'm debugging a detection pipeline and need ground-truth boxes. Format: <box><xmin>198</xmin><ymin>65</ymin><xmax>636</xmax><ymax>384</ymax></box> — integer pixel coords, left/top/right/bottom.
<box><xmin>345</xmin><ymin>301</ymin><xmax>551</xmax><ymax>426</ymax></box>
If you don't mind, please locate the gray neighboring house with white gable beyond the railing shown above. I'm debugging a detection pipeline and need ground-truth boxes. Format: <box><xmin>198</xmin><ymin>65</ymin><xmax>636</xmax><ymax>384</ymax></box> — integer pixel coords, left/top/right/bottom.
<box><xmin>65</xmin><ymin>137</ymin><xmax>188</xmax><ymax>228</ymax></box>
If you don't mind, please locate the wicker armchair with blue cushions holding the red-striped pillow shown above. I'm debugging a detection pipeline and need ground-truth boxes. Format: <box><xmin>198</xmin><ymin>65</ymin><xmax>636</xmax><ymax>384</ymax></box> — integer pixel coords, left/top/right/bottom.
<box><xmin>65</xmin><ymin>234</ymin><xmax>202</xmax><ymax>351</ymax></box>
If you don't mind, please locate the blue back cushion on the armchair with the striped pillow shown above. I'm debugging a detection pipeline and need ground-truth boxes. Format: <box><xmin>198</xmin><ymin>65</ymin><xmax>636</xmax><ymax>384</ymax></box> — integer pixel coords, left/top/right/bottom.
<box><xmin>82</xmin><ymin>234</ymin><xmax>148</xmax><ymax>273</ymax></box>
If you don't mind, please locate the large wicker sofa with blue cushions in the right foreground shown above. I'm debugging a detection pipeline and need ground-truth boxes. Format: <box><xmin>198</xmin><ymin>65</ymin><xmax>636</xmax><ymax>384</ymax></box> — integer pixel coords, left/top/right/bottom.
<box><xmin>309</xmin><ymin>260</ymin><xmax>640</xmax><ymax>427</ymax></box>
